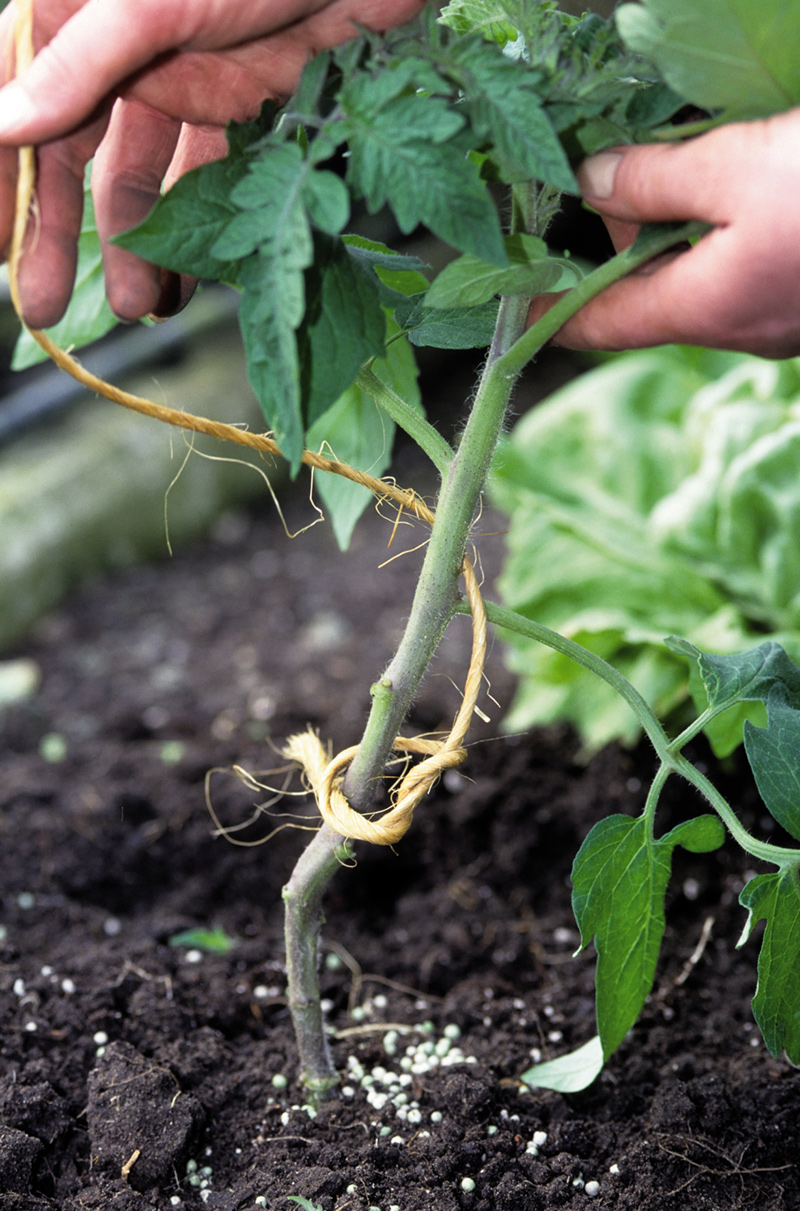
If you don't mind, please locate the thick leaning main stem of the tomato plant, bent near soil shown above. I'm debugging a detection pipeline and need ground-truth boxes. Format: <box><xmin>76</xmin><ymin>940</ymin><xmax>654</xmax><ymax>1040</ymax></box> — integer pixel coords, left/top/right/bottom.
<box><xmin>283</xmin><ymin>298</ymin><xmax>528</xmax><ymax>1098</ymax></box>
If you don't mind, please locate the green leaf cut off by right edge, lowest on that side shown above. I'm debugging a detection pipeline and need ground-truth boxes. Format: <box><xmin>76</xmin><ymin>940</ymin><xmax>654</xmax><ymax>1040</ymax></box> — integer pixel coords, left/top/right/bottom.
<box><xmin>738</xmin><ymin>867</ymin><xmax>800</xmax><ymax>1066</ymax></box>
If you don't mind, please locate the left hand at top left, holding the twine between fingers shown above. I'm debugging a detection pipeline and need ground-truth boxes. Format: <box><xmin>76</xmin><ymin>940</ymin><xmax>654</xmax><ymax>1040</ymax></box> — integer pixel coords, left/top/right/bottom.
<box><xmin>0</xmin><ymin>0</ymin><xmax>424</xmax><ymax>328</ymax></box>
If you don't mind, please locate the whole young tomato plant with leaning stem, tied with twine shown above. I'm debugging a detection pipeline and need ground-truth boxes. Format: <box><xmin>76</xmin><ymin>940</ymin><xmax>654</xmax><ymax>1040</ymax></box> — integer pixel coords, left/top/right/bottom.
<box><xmin>14</xmin><ymin>0</ymin><xmax>800</xmax><ymax>1097</ymax></box>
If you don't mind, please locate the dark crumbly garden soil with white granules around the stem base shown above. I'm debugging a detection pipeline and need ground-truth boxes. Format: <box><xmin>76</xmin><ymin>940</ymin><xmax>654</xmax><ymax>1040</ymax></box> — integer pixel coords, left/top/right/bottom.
<box><xmin>0</xmin><ymin>455</ymin><xmax>800</xmax><ymax>1211</ymax></box>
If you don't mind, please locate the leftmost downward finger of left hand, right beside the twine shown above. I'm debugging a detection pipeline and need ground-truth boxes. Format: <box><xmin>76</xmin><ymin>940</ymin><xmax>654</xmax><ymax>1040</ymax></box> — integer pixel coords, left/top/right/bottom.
<box><xmin>17</xmin><ymin>120</ymin><xmax>104</xmax><ymax>328</ymax></box>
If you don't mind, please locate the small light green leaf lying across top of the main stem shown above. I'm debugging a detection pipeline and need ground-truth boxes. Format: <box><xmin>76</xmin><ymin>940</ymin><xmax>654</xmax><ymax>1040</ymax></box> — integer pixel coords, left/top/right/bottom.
<box><xmin>425</xmin><ymin>234</ymin><xmax>581</xmax><ymax>310</ymax></box>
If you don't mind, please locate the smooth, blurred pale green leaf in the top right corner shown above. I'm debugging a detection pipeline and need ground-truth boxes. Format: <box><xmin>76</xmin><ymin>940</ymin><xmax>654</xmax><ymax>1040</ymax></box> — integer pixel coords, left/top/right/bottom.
<box><xmin>616</xmin><ymin>0</ymin><xmax>800</xmax><ymax>121</ymax></box>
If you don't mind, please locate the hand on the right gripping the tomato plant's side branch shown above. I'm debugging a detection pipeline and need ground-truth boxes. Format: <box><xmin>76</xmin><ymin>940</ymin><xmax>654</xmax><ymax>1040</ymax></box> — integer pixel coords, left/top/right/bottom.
<box><xmin>530</xmin><ymin>109</ymin><xmax>800</xmax><ymax>357</ymax></box>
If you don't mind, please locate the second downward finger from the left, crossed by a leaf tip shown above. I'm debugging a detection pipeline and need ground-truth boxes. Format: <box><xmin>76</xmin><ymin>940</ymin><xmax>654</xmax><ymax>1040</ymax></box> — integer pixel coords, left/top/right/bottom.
<box><xmin>92</xmin><ymin>101</ymin><xmax>180</xmax><ymax>320</ymax></box>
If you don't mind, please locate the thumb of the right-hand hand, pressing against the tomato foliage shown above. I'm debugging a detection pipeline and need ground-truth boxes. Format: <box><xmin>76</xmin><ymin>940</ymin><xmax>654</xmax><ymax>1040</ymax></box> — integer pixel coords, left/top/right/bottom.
<box><xmin>577</xmin><ymin>126</ymin><xmax>747</xmax><ymax>224</ymax></box>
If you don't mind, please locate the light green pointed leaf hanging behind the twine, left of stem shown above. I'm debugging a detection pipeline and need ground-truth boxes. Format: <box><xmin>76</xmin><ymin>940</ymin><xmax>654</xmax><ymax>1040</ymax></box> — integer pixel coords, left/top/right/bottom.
<box><xmin>306</xmin><ymin>325</ymin><xmax>421</xmax><ymax>551</ymax></box>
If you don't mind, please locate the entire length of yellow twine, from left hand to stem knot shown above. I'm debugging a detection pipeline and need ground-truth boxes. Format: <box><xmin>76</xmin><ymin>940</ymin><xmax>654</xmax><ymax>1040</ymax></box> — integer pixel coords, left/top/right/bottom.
<box><xmin>8</xmin><ymin>0</ymin><xmax>487</xmax><ymax>845</ymax></box>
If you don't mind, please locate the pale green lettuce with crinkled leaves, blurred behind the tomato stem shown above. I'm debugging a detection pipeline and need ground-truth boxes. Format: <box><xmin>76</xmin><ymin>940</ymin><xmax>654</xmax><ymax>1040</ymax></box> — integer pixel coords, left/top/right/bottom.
<box><xmin>493</xmin><ymin>349</ymin><xmax>800</xmax><ymax>756</ymax></box>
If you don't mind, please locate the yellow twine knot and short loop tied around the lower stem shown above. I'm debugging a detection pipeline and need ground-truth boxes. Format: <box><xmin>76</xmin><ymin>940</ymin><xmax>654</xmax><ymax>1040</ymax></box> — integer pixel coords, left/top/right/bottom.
<box><xmin>283</xmin><ymin>558</ymin><xmax>487</xmax><ymax>845</ymax></box>
